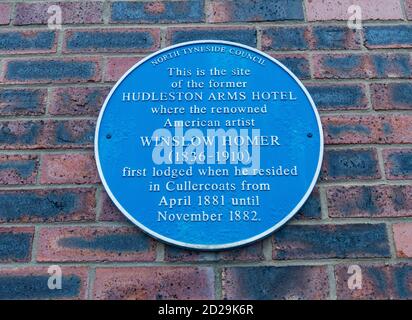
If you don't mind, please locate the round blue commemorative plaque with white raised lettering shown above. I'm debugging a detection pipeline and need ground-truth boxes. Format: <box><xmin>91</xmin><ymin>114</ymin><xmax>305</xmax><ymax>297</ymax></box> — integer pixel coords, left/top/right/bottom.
<box><xmin>95</xmin><ymin>40</ymin><xmax>323</xmax><ymax>249</ymax></box>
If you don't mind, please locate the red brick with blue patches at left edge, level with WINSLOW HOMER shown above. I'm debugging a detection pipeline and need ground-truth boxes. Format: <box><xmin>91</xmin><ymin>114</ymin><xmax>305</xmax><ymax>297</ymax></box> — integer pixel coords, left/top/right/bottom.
<box><xmin>0</xmin><ymin>120</ymin><xmax>96</xmax><ymax>150</ymax></box>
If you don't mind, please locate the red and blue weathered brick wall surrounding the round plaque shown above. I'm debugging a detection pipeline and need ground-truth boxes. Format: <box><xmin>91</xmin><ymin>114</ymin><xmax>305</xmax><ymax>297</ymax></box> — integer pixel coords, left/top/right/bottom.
<box><xmin>0</xmin><ymin>0</ymin><xmax>412</xmax><ymax>299</ymax></box>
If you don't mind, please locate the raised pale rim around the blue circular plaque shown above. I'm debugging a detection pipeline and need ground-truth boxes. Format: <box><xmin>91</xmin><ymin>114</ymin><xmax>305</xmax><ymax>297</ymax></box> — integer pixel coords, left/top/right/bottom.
<box><xmin>94</xmin><ymin>39</ymin><xmax>324</xmax><ymax>251</ymax></box>
